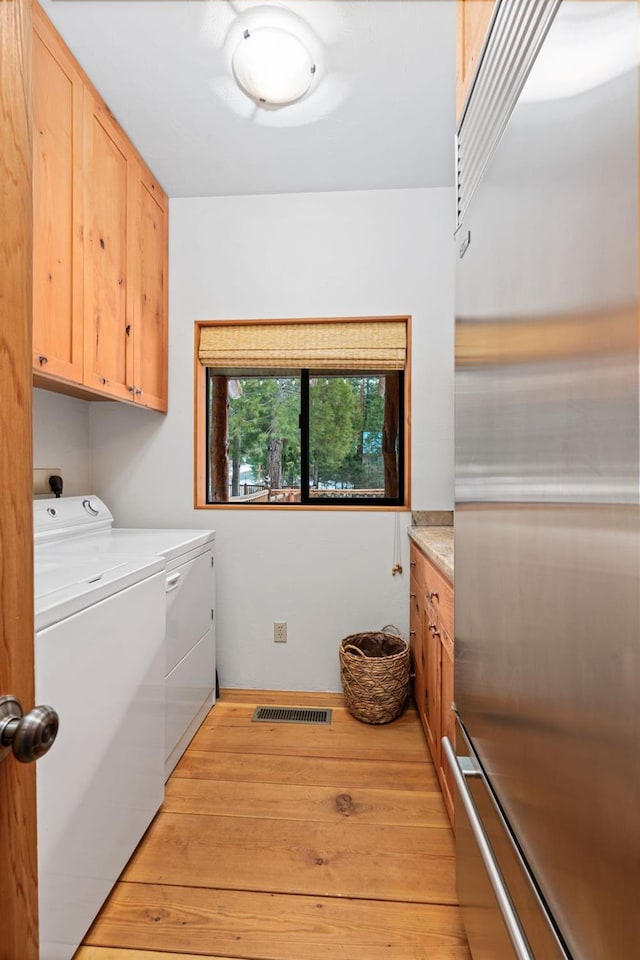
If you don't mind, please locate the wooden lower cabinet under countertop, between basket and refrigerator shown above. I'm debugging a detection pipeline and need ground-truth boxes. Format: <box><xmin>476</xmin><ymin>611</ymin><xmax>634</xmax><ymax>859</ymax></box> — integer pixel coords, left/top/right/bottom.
<box><xmin>409</xmin><ymin>544</ymin><xmax>456</xmax><ymax>826</ymax></box>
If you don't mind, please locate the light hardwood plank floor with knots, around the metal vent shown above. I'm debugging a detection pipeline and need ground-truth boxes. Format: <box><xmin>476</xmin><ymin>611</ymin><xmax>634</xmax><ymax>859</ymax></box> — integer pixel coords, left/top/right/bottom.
<box><xmin>75</xmin><ymin>691</ymin><xmax>470</xmax><ymax>960</ymax></box>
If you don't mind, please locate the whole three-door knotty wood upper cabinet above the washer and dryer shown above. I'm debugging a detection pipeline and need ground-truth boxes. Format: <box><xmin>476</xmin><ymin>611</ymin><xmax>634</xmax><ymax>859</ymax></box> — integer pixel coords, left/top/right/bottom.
<box><xmin>33</xmin><ymin>3</ymin><xmax>168</xmax><ymax>412</ymax></box>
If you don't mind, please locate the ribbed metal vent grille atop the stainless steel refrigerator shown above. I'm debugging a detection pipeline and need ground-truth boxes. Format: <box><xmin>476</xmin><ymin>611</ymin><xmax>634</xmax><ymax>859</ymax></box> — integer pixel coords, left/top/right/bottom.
<box><xmin>456</xmin><ymin>0</ymin><xmax>561</xmax><ymax>226</ymax></box>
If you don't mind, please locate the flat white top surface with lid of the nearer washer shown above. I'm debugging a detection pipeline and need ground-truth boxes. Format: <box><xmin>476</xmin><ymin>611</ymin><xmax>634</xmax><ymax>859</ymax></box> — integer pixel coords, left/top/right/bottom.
<box><xmin>34</xmin><ymin>550</ymin><xmax>164</xmax><ymax>630</ymax></box>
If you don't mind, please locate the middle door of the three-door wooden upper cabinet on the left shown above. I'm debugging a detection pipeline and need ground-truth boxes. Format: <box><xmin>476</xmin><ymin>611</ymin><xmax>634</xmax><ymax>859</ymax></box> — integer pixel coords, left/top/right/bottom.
<box><xmin>84</xmin><ymin>88</ymin><xmax>137</xmax><ymax>400</ymax></box>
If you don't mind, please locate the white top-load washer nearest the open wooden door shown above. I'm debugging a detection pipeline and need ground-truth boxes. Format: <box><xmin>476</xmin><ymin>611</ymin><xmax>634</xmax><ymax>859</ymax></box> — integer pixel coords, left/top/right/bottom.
<box><xmin>34</xmin><ymin>500</ymin><xmax>165</xmax><ymax>960</ymax></box>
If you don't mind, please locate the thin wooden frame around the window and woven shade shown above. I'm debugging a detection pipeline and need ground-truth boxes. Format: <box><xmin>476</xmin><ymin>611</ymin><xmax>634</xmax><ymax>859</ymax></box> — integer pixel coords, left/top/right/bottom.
<box><xmin>194</xmin><ymin>316</ymin><xmax>411</xmax><ymax>512</ymax></box>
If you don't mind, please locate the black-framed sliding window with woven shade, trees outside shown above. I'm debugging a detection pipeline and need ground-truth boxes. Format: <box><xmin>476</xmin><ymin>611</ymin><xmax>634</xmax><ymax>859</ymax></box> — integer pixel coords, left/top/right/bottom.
<box><xmin>196</xmin><ymin>319</ymin><xmax>408</xmax><ymax>507</ymax></box>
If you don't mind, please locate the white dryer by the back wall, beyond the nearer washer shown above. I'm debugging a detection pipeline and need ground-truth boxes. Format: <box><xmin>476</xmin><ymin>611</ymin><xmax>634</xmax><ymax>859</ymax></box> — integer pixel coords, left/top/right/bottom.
<box><xmin>36</xmin><ymin>496</ymin><xmax>216</xmax><ymax>779</ymax></box>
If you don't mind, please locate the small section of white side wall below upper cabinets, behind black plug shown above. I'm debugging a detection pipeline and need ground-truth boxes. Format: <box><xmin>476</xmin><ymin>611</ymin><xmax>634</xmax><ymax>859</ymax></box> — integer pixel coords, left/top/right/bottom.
<box><xmin>33</xmin><ymin>390</ymin><xmax>91</xmax><ymax>496</ymax></box>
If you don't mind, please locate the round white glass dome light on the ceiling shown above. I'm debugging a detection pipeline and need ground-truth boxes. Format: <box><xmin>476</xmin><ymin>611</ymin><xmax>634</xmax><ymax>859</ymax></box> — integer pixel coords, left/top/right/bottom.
<box><xmin>232</xmin><ymin>26</ymin><xmax>316</xmax><ymax>107</ymax></box>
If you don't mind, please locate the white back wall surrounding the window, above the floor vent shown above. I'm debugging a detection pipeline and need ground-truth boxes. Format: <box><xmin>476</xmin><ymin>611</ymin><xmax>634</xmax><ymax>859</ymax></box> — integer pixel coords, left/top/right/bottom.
<box><xmin>91</xmin><ymin>189</ymin><xmax>454</xmax><ymax>690</ymax></box>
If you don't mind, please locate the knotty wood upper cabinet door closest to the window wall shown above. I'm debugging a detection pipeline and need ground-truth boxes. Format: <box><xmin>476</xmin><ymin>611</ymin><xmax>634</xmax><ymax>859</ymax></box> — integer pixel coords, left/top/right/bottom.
<box><xmin>129</xmin><ymin>168</ymin><xmax>168</xmax><ymax>412</ymax></box>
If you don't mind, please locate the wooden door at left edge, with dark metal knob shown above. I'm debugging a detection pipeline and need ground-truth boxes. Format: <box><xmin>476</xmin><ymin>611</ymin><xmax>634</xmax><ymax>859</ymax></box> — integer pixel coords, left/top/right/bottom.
<box><xmin>0</xmin><ymin>0</ymin><xmax>38</xmax><ymax>960</ymax></box>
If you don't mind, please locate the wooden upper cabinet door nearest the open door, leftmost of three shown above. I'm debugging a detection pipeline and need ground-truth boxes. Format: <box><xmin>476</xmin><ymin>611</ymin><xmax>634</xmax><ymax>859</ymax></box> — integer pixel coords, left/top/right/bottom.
<box><xmin>33</xmin><ymin>10</ymin><xmax>83</xmax><ymax>383</ymax></box>
